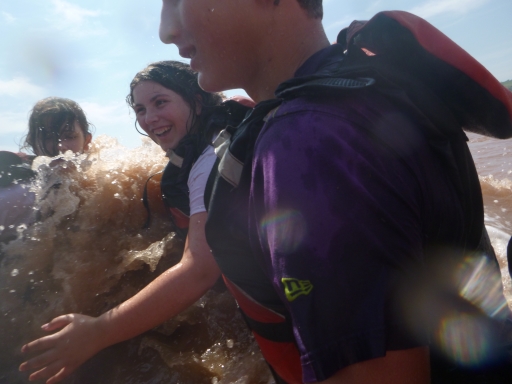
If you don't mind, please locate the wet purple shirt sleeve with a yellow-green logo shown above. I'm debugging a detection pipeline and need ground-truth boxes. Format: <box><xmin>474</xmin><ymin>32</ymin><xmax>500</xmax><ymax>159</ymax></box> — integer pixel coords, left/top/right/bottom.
<box><xmin>250</xmin><ymin>95</ymin><xmax>460</xmax><ymax>382</ymax></box>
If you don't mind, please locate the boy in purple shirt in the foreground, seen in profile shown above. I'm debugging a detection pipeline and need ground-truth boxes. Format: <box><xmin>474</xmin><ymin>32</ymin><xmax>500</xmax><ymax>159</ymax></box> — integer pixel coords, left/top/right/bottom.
<box><xmin>160</xmin><ymin>0</ymin><xmax>510</xmax><ymax>383</ymax></box>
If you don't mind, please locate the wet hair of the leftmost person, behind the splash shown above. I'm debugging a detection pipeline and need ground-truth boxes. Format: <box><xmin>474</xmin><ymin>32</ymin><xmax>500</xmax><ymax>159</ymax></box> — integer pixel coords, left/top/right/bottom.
<box><xmin>22</xmin><ymin>97</ymin><xmax>91</xmax><ymax>156</ymax></box>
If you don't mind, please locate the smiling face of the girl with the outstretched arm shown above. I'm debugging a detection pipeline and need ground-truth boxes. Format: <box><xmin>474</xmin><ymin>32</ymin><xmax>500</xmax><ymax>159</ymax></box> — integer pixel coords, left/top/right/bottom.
<box><xmin>133</xmin><ymin>81</ymin><xmax>196</xmax><ymax>152</ymax></box>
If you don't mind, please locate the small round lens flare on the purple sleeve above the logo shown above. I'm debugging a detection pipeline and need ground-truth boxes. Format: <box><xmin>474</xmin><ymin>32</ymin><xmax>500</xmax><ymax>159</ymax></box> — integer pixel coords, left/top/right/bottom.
<box><xmin>260</xmin><ymin>210</ymin><xmax>307</xmax><ymax>253</ymax></box>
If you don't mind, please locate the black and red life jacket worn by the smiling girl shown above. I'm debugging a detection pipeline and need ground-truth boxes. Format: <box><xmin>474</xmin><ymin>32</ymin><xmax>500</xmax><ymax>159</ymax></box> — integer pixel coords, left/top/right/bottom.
<box><xmin>142</xmin><ymin>98</ymin><xmax>250</xmax><ymax>238</ymax></box>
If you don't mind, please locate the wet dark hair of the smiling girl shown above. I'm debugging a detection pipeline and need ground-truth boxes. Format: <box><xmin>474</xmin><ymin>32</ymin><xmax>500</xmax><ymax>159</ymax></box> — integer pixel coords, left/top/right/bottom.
<box><xmin>126</xmin><ymin>60</ymin><xmax>223</xmax><ymax>150</ymax></box>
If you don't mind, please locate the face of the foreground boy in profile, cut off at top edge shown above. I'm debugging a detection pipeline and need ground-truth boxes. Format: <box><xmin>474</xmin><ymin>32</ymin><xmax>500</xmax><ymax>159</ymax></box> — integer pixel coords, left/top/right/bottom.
<box><xmin>160</xmin><ymin>0</ymin><xmax>257</xmax><ymax>92</ymax></box>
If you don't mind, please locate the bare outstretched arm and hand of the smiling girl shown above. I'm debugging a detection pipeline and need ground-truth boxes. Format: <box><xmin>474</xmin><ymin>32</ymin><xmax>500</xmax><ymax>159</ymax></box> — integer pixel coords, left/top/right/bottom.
<box><xmin>20</xmin><ymin>212</ymin><xmax>220</xmax><ymax>384</ymax></box>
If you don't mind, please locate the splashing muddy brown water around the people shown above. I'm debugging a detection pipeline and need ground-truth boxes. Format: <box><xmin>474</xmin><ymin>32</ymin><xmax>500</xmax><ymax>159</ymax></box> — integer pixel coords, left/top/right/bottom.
<box><xmin>0</xmin><ymin>135</ymin><xmax>512</xmax><ymax>384</ymax></box>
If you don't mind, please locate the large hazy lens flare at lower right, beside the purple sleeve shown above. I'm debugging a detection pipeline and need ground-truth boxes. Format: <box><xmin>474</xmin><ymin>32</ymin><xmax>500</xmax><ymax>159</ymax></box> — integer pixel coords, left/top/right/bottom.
<box><xmin>402</xmin><ymin>250</ymin><xmax>510</xmax><ymax>369</ymax></box>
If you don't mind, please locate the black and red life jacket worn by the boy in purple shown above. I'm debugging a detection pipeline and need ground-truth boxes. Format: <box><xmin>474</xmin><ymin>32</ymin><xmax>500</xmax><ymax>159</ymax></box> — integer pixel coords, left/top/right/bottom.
<box><xmin>206</xmin><ymin>11</ymin><xmax>512</xmax><ymax>383</ymax></box>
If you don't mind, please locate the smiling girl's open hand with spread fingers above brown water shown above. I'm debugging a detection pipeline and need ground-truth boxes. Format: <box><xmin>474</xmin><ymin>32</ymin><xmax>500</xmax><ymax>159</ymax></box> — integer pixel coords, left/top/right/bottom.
<box><xmin>19</xmin><ymin>314</ymin><xmax>108</xmax><ymax>384</ymax></box>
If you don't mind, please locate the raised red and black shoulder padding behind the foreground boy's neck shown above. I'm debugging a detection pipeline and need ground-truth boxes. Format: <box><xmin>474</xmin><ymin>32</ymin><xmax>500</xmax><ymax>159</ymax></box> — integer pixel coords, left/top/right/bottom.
<box><xmin>338</xmin><ymin>11</ymin><xmax>512</xmax><ymax>139</ymax></box>
